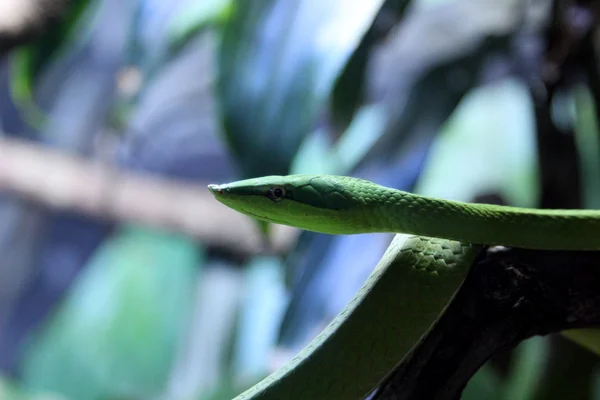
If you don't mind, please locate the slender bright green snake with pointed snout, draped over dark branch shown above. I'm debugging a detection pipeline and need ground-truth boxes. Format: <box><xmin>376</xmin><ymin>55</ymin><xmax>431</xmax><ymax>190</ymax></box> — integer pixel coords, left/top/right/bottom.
<box><xmin>209</xmin><ymin>175</ymin><xmax>600</xmax><ymax>400</ymax></box>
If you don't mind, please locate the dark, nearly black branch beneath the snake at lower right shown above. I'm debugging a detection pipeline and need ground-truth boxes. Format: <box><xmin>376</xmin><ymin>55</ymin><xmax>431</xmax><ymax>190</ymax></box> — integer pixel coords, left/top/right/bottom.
<box><xmin>375</xmin><ymin>248</ymin><xmax>600</xmax><ymax>400</ymax></box>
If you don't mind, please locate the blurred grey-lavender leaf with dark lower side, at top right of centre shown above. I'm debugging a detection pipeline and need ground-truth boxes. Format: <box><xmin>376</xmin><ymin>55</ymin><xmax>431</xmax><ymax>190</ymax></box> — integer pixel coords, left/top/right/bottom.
<box><xmin>365</xmin><ymin>0</ymin><xmax>524</xmax><ymax>166</ymax></box>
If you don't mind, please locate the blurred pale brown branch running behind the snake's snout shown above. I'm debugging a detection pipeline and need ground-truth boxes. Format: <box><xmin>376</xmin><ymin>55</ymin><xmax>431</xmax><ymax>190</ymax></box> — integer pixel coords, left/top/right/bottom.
<box><xmin>0</xmin><ymin>138</ymin><xmax>297</xmax><ymax>256</ymax></box>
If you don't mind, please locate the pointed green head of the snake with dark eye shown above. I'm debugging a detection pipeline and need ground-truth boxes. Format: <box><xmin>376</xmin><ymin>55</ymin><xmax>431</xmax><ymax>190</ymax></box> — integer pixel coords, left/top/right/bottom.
<box><xmin>208</xmin><ymin>175</ymin><xmax>372</xmax><ymax>234</ymax></box>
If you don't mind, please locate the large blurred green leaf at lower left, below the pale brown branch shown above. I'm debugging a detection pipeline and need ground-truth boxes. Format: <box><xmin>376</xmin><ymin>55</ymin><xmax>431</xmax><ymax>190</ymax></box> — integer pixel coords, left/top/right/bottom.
<box><xmin>23</xmin><ymin>228</ymin><xmax>200</xmax><ymax>400</ymax></box>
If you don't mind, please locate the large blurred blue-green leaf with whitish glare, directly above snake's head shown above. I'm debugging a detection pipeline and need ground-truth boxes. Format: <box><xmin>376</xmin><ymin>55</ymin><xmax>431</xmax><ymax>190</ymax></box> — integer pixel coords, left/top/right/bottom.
<box><xmin>218</xmin><ymin>0</ymin><xmax>383</xmax><ymax>176</ymax></box>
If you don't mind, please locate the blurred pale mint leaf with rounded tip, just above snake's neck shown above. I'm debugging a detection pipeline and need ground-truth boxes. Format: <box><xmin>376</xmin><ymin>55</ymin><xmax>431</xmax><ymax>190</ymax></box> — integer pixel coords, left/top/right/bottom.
<box><xmin>416</xmin><ymin>78</ymin><xmax>538</xmax><ymax>207</ymax></box>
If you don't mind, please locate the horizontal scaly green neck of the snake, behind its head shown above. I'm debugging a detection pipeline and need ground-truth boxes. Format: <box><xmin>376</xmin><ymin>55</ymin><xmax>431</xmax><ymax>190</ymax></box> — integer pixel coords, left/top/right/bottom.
<box><xmin>357</xmin><ymin>188</ymin><xmax>600</xmax><ymax>250</ymax></box>
